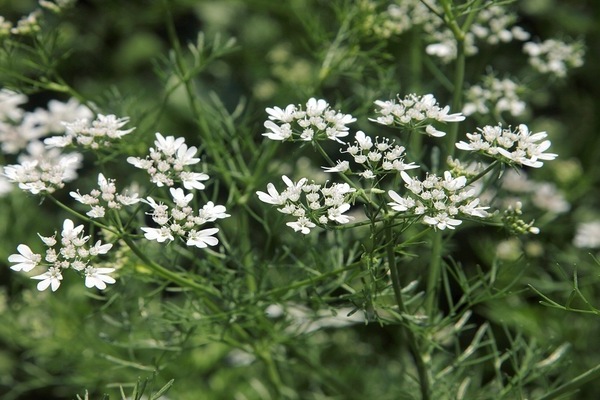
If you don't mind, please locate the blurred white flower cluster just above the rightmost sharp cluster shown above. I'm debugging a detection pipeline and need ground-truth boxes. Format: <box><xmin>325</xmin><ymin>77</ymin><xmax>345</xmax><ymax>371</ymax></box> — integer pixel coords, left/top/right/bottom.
<box><xmin>462</xmin><ymin>76</ymin><xmax>526</xmax><ymax>117</ymax></box>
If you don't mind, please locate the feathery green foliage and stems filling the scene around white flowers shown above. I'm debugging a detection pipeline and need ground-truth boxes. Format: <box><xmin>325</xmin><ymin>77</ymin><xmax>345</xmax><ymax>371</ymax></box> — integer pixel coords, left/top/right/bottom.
<box><xmin>0</xmin><ymin>0</ymin><xmax>600</xmax><ymax>400</ymax></box>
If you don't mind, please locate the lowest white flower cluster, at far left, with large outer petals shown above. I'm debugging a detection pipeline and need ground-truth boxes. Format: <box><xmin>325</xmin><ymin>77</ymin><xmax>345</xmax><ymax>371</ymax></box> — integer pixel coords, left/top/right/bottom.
<box><xmin>8</xmin><ymin>219</ymin><xmax>115</xmax><ymax>292</ymax></box>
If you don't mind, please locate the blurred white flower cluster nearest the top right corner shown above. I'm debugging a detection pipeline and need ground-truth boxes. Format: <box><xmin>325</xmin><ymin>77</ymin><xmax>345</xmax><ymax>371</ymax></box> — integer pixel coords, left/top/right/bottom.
<box><xmin>523</xmin><ymin>39</ymin><xmax>584</xmax><ymax>78</ymax></box>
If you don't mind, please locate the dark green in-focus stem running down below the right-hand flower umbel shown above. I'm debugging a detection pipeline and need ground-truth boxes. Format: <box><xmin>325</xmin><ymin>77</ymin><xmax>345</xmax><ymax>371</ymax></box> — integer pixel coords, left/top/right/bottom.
<box><xmin>385</xmin><ymin>227</ymin><xmax>431</xmax><ymax>400</ymax></box>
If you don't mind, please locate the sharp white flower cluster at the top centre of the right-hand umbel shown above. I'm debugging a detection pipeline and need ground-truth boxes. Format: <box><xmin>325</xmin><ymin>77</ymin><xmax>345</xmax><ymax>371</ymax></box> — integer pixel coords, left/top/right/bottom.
<box><xmin>370</xmin><ymin>94</ymin><xmax>465</xmax><ymax>137</ymax></box>
